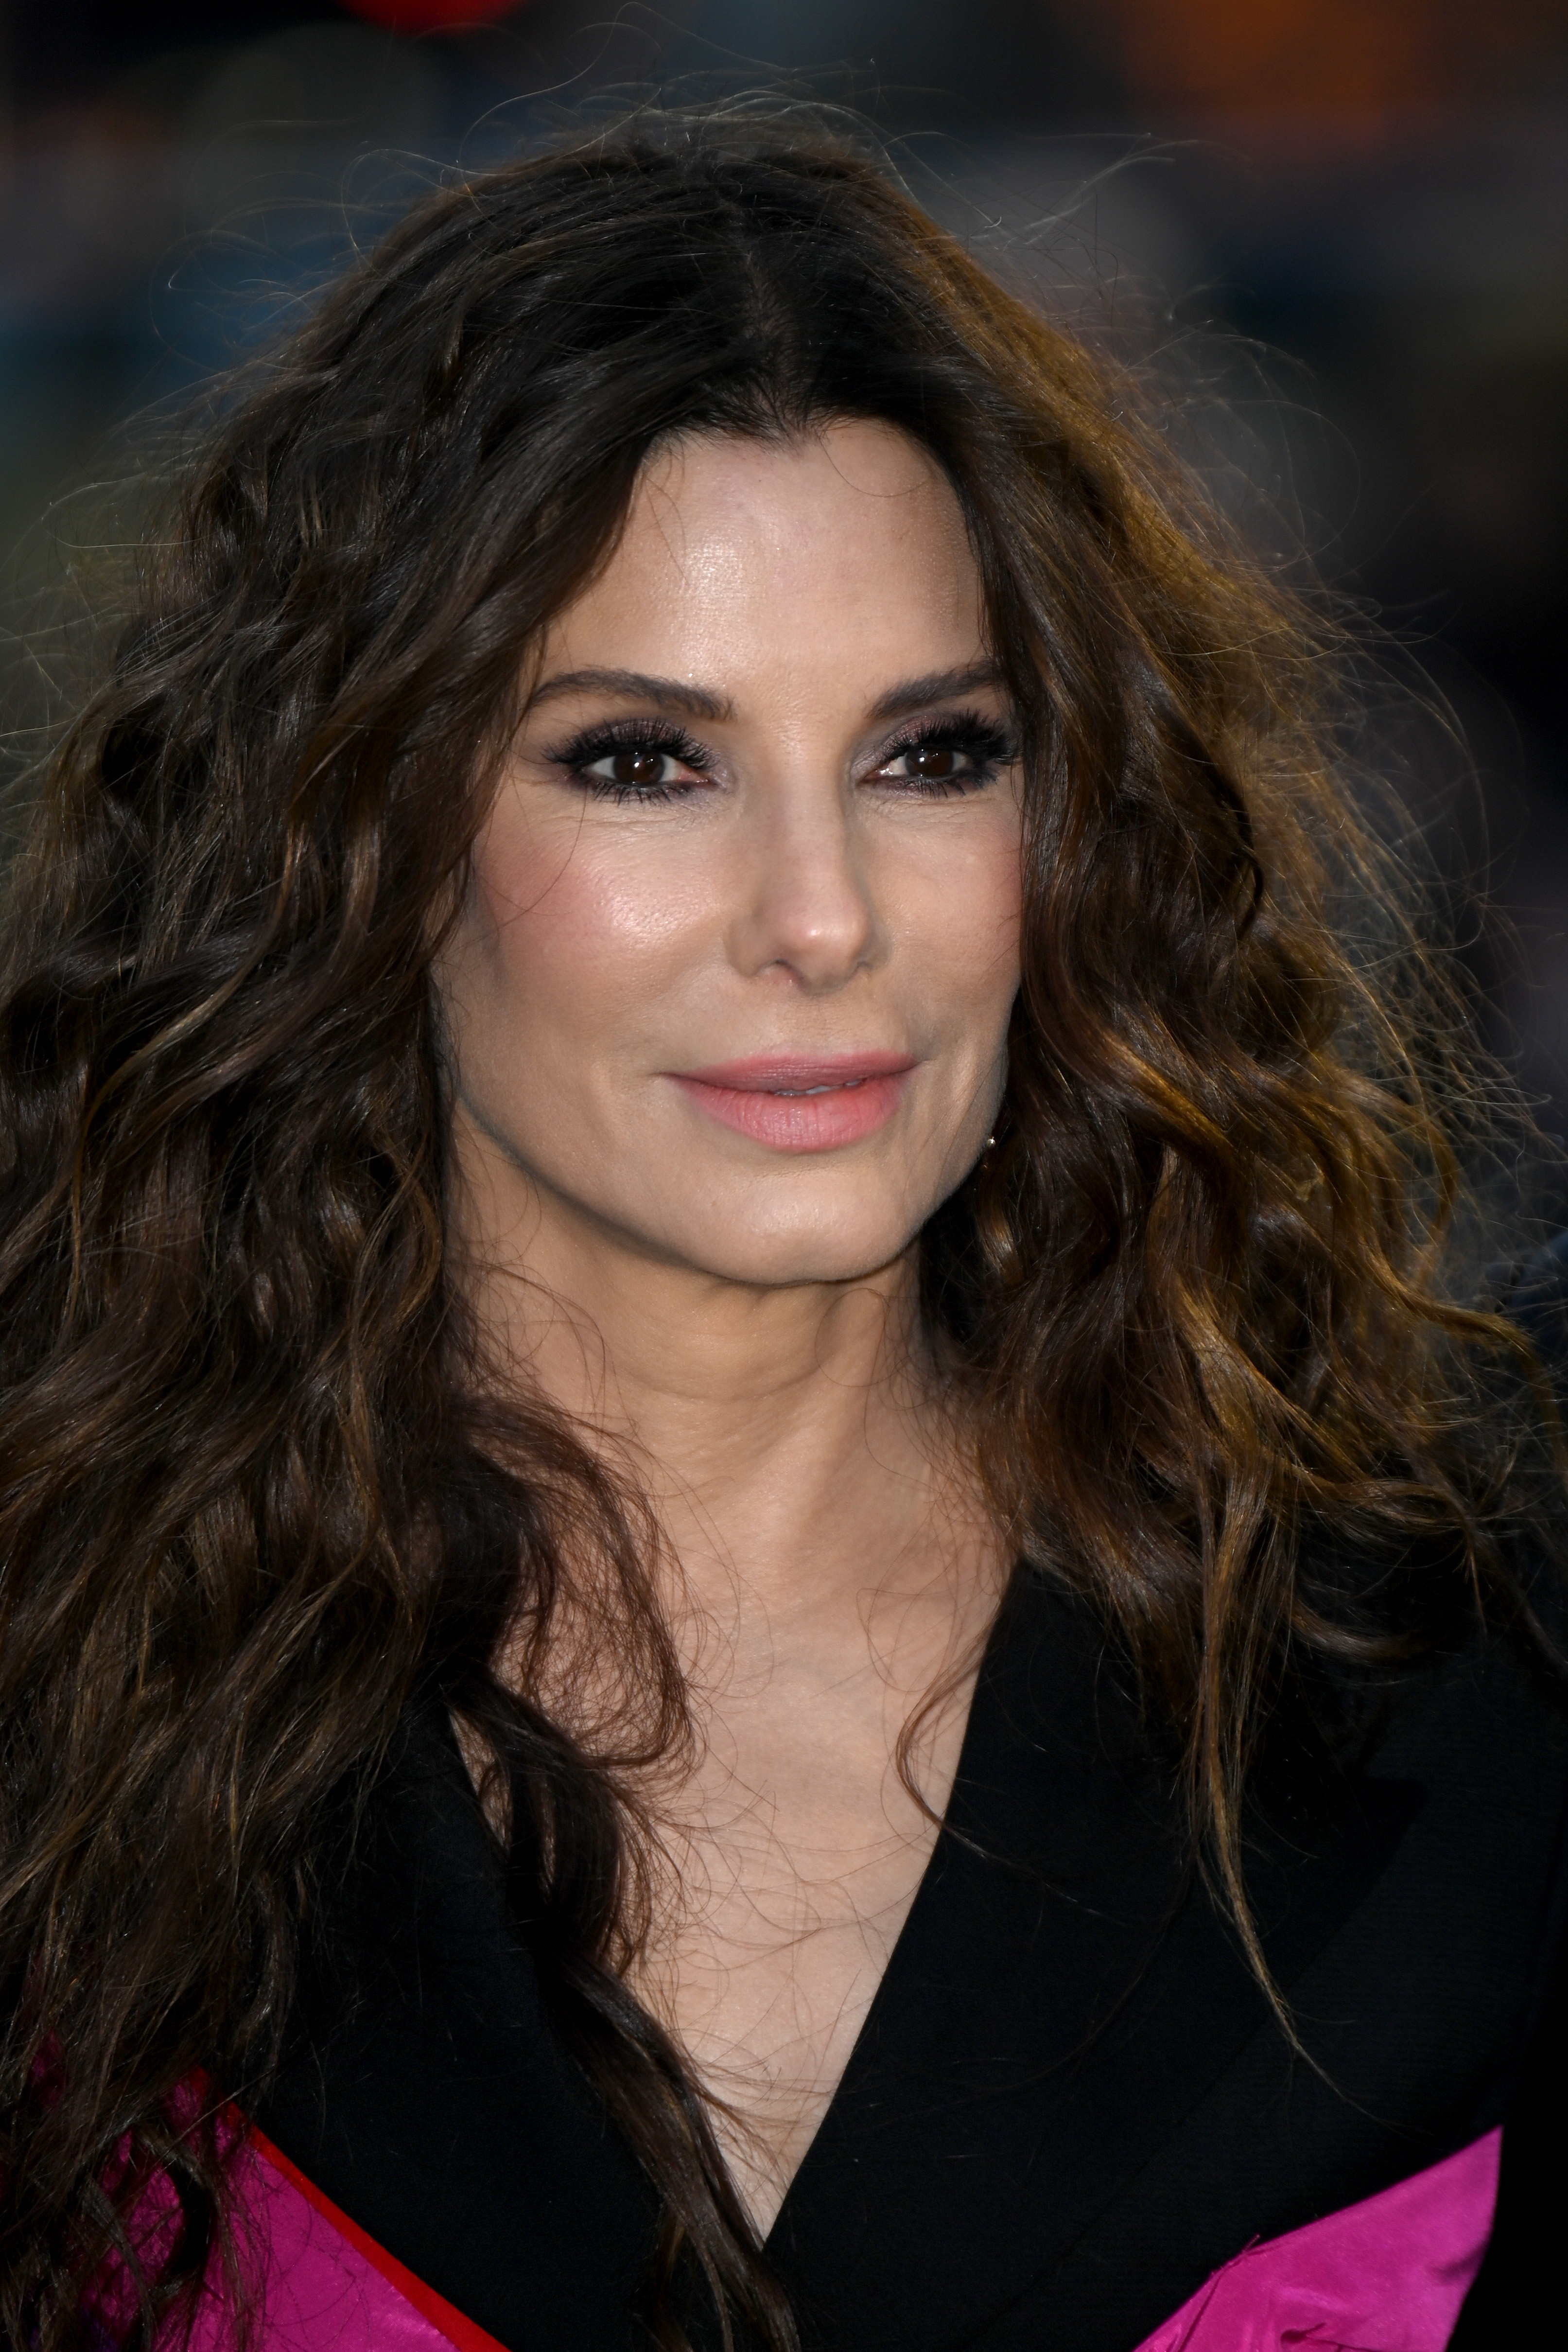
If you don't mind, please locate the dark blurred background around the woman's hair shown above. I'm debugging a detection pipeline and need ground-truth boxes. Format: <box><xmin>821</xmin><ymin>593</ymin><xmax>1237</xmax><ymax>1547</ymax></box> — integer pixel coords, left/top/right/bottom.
<box><xmin>0</xmin><ymin>0</ymin><xmax>1568</xmax><ymax>1157</ymax></box>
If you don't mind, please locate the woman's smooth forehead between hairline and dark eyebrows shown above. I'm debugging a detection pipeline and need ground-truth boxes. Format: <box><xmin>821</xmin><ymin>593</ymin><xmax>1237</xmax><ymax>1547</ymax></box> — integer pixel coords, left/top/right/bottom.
<box><xmin>545</xmin><ymin>421</ymin><xmax>985</xmax><ymax>687</ymax></box>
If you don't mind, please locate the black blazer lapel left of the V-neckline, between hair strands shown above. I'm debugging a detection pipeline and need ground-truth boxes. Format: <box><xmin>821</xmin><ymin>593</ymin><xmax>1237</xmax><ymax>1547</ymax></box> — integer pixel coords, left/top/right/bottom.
<box><xmin>252</xmin><ymin>1710</ymin><xmax>656</xmax><ymax>2352</ymax></box>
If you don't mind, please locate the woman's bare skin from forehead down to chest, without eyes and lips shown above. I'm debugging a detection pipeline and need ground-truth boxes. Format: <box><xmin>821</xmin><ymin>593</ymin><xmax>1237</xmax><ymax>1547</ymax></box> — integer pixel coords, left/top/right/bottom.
<box><xmin>442</xmin><ymin>423</ymin><xmax>1020</xmax><ymax>2232</ymax></box>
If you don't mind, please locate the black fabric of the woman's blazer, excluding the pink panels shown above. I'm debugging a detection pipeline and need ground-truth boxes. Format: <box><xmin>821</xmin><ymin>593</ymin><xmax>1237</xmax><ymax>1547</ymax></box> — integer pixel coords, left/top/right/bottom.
<box><xmin>256</xmin><ymin>1524</ymin><xmax>1568</xmax><ymax>2352</ymax></box>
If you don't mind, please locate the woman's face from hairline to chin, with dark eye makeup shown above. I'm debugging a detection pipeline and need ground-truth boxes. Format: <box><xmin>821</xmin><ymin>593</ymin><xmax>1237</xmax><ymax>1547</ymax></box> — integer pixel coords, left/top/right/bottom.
<box><xmin>442</xmin><ymin>423</ymin><xmax>1020</xmax><ymax>1284</ymax></box>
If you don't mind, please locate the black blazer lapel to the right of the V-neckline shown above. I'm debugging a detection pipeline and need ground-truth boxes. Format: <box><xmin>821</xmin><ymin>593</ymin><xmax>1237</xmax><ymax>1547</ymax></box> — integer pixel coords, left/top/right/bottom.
<box><xmin>769</xmin><ymin>1592</ymin><xmax>1422</xmax><ymax>2352</ymax></box>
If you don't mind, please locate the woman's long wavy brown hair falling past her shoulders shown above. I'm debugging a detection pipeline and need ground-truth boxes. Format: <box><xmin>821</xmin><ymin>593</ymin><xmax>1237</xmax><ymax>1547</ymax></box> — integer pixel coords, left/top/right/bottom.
<box><xmin>0</xmin><ymin>113</ymin><xmax>1551</xmax><ymax>2352</ymax></box>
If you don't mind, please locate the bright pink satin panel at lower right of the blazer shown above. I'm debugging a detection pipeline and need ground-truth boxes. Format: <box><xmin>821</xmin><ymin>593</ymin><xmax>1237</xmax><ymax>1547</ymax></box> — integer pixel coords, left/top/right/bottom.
<box><xmin>1138</xmin><ymin>2131</ymin><xmax>1502</xmax><ymax>2352</ymax></box>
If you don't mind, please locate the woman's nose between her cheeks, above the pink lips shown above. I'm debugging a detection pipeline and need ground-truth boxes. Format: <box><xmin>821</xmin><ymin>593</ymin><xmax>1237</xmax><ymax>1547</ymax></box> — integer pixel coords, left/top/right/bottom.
<box><xmin>729</xmin><ymin>790</ymin><xmax>882</xmax><ymax>995</ymax></box>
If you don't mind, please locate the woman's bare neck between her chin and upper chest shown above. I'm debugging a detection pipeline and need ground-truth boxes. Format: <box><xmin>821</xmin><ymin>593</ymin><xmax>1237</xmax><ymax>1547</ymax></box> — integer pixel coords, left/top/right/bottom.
<box><xmin>453</xmin><ymin>1117</ymin><xmax>990</xmax><ymax>1649</ymax></box>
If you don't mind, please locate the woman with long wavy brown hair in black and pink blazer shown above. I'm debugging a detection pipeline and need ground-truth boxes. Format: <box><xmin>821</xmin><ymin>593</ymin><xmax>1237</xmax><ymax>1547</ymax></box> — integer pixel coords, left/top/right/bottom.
<box><xmin>0</xmin><ymin>120</ymin><xmax>1568</xmax><ymax>2352</ymax></box>
